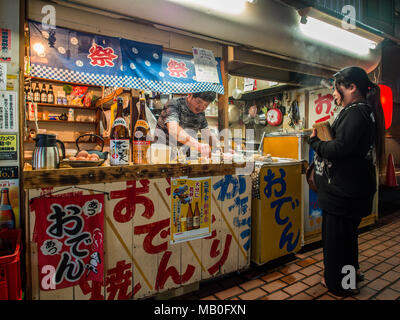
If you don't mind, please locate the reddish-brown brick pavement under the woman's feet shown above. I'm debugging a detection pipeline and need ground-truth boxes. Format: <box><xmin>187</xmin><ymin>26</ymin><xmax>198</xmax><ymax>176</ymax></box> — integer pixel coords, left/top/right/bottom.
<box><xmin>174</xmin><ymin>211</ymin><xmax>400</xmax><ymax>300</ymax></box>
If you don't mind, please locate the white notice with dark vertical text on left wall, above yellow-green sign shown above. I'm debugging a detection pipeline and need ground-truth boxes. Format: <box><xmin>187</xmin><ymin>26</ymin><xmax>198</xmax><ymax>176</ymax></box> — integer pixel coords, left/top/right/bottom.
<box><xmin>0</xmin><ymin>91</ymin><xmax>17</xmax><ymax>132</ymax></box>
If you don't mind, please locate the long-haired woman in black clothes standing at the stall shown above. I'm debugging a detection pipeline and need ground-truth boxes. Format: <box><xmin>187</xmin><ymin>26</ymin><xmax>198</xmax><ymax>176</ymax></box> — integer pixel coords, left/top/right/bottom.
<box><xmin>309</xmin><ymin>66</ymin><xmax>384</xmax><ymax>296</ymax></box>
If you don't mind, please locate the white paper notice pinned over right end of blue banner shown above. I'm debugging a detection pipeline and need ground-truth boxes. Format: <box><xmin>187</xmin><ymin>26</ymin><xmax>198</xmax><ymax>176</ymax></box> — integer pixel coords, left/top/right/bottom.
<box><xmin>192</xmin><ymin>48</ymin><xmax>219</xmax><ymax>83</ymax></box>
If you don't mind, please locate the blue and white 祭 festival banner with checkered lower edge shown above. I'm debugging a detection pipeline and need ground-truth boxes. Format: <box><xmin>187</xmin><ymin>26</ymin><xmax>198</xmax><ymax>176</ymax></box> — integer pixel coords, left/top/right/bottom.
<box><xmin>29</xmin><ymin>22</ymin><xmax>224</xmax><ymax>94</ymax></box>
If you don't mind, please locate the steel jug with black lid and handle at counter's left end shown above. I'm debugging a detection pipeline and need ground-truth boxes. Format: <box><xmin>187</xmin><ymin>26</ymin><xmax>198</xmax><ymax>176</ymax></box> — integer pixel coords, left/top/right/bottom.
<box><xmin>32</xmin><ymin>134</ymin><xmax>65</xmax><ymax>169</ymax></box>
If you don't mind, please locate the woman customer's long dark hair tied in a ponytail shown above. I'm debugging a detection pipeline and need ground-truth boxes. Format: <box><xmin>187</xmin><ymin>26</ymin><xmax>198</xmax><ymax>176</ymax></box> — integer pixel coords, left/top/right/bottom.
<box><xmin>334</xmin><ymin>66</ymin><xmax>385</xmax><ymax>167</ymax></box>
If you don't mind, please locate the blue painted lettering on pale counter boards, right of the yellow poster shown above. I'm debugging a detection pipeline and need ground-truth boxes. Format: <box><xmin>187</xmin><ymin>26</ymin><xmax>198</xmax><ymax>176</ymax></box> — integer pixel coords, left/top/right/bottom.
<box><xmin>213</xmin><ymin>175</ymin><xmax>251</xmax><ymax>250</ymax></box>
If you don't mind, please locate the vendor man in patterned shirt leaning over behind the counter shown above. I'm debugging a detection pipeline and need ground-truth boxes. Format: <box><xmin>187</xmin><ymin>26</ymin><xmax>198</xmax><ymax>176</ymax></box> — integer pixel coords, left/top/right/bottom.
<box><xmin>155</xmin><ymin>91</ymin><xmax>217</xmax><ymax>156</ymax></box>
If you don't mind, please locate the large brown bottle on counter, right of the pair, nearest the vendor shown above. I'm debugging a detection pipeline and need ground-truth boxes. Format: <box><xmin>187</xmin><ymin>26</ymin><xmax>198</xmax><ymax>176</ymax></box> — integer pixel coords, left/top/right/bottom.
<box><xmin>132</xmin><ymin>93</ymin><xmax>150</xmax><ymax>164</ymax></box>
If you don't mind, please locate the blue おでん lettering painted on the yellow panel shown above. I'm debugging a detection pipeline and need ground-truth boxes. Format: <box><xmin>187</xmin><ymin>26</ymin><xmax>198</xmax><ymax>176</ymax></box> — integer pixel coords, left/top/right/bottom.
<box><xmin>264</xmin><ymin>168</ymin><xmax>300</xmax><ymax>252</ymax></box>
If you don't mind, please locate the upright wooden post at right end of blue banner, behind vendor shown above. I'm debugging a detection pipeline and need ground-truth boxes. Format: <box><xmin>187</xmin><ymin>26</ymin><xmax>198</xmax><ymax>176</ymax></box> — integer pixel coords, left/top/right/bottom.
<box><xmin>218</xmin><ymin>46</ymin><xmax>229</xmax><ymax>131</ymax></box>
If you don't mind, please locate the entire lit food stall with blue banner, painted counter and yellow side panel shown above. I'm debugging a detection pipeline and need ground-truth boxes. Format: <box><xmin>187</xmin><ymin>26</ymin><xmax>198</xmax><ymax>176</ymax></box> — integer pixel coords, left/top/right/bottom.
<box><xmin>0</xmin><ymin>0</ymin><xmax>384</xmax><ymax>300</ymax></box>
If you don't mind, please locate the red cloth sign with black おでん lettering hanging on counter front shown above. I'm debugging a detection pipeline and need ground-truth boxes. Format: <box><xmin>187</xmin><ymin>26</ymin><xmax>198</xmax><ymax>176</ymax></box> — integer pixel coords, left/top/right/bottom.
<box><xmin>31</xmin><ymin>194</ymin><xmax>104</xmax><ymax>290</ymax></box>
